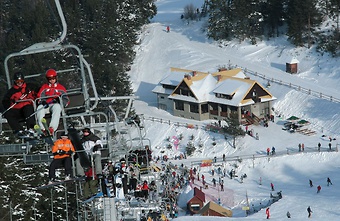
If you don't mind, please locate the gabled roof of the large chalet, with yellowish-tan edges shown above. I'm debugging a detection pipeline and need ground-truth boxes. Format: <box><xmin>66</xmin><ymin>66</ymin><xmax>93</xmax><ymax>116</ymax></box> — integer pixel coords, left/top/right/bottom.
<box><xmin>153</xmin><ymin>68</ymin><xmax>276</xmax><ymax>106</ymax></box>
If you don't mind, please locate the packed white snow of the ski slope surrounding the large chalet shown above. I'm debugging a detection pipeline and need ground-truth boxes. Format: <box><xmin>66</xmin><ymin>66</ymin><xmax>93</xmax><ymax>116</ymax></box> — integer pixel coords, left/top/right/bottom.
<box><xmin>130</xmin><ymin>0</ymin><xmax>340</xmax><ymax>221</ymax></box>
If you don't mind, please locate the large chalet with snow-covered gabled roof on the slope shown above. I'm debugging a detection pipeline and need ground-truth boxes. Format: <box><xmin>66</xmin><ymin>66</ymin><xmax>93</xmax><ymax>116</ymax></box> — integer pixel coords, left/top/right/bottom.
<box><xmin>153</xmin><ymin>68</ymin><xmax>276</xmax><ymax>124</ymax></box>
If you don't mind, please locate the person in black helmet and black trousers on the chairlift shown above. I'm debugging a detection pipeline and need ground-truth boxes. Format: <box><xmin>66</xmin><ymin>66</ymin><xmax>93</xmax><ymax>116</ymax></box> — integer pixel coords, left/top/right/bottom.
<box><xmin>2</xmin><ymin>72</ymin><xmax>37</xmax><ymax>136</ymax></box>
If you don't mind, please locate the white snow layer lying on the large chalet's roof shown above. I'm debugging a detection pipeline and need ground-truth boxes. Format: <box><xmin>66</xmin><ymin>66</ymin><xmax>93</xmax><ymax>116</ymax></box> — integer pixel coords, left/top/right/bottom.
<box><xmin>152</xmin><ymin>68</ymin><xmax>276</xmax><ymax>106</ymax></box>
